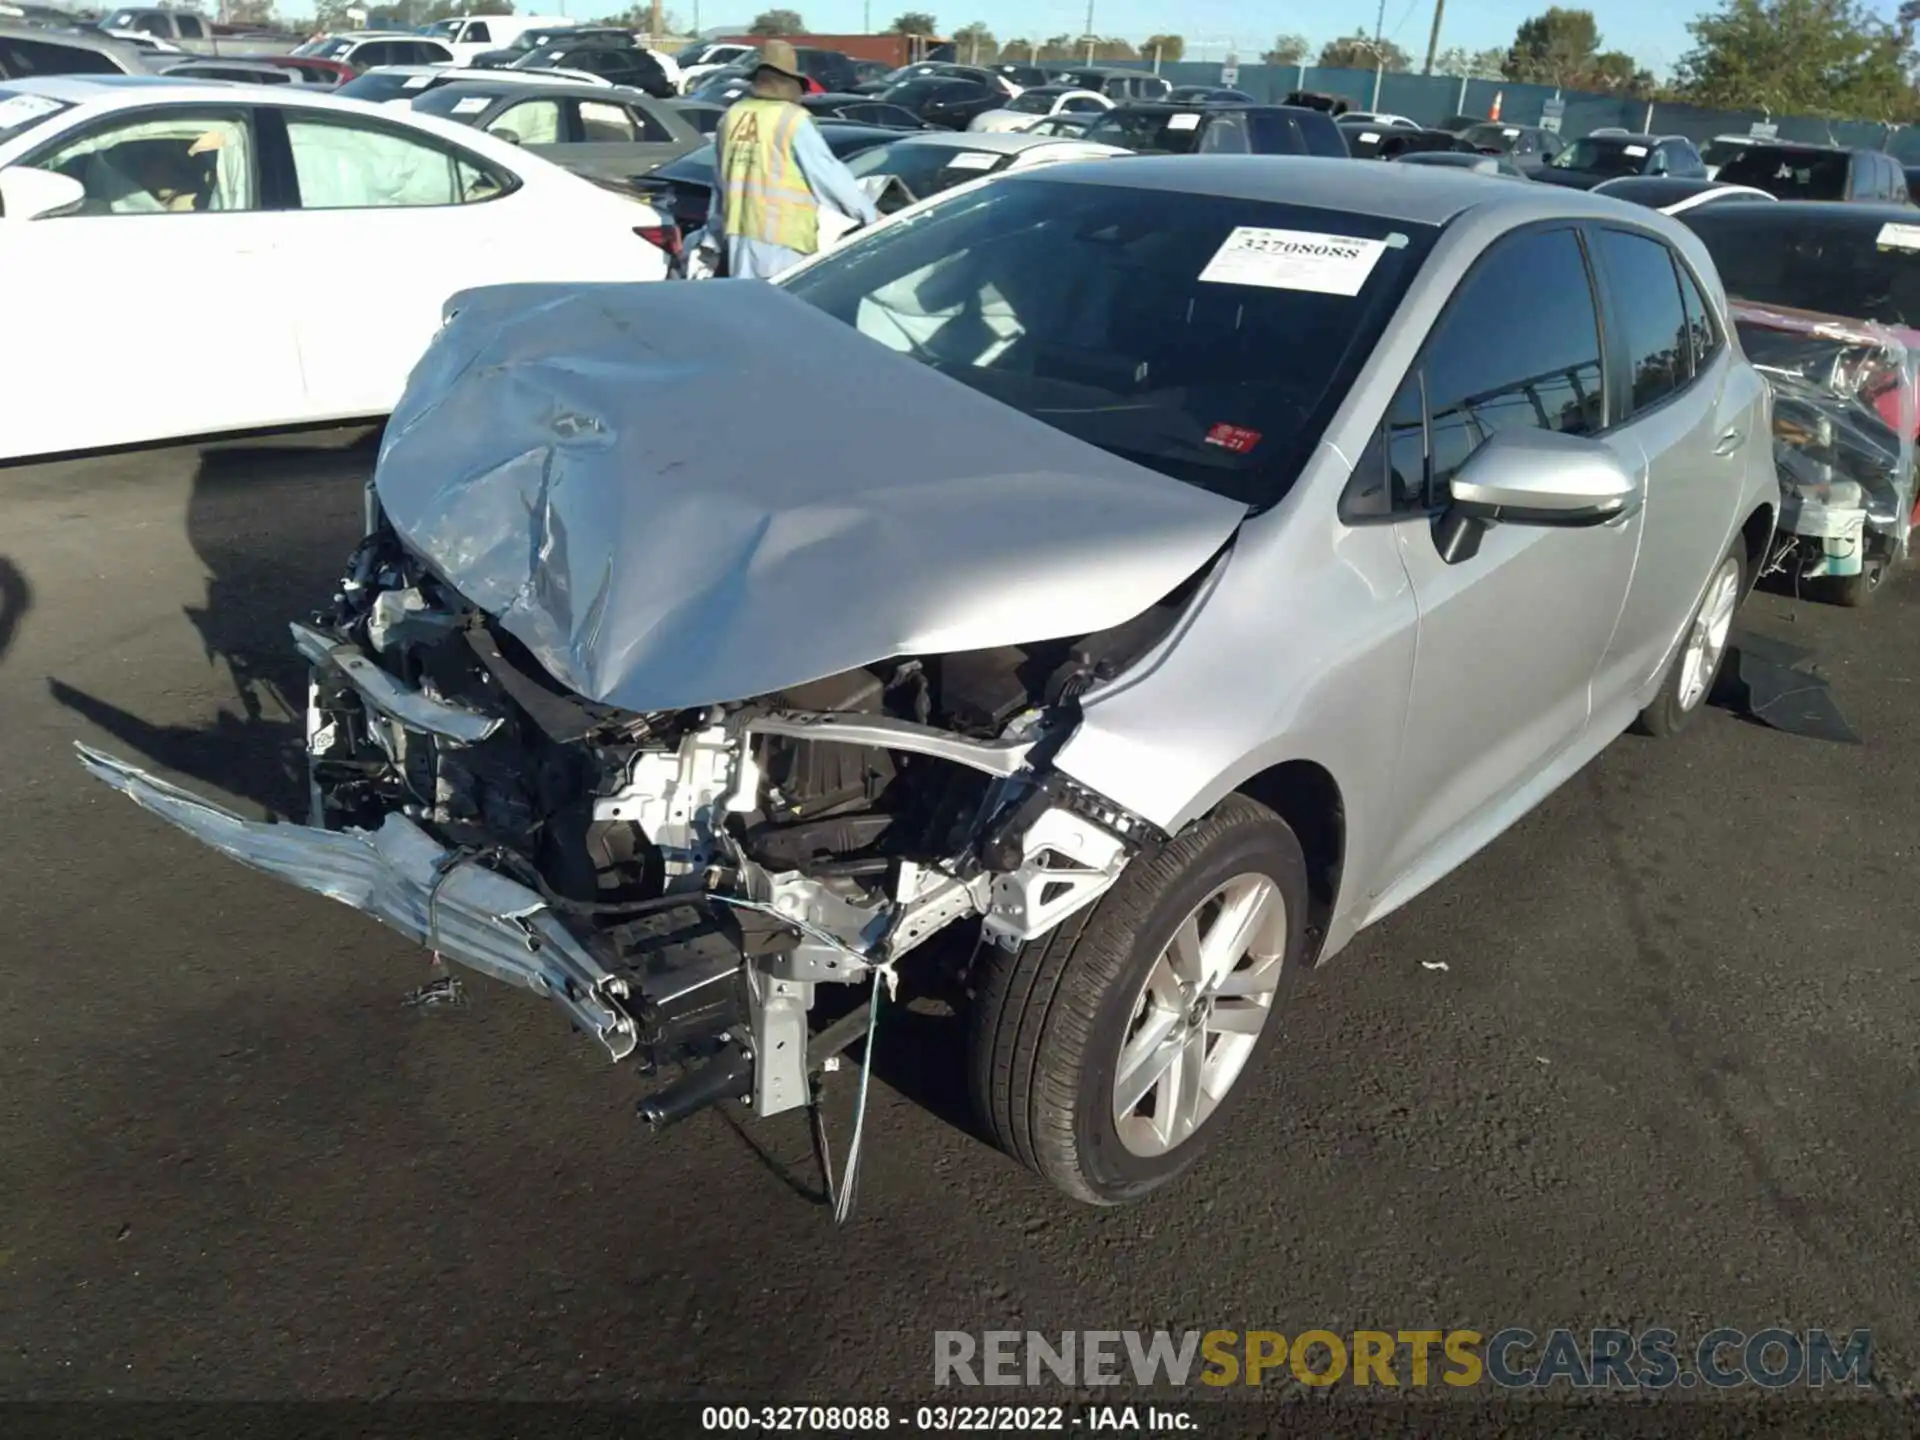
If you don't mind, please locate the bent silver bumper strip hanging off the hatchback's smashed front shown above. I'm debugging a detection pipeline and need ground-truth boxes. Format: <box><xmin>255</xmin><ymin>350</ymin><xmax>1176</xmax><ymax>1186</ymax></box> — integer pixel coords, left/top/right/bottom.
<box><xmin>75</xmin><ymin>745</ymin><xmax>639</xmax><ymax>1060</ymax></box>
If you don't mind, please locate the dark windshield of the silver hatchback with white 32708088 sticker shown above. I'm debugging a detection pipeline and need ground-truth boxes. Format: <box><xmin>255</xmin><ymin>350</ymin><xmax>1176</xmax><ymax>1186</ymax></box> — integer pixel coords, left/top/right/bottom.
<box><xmin>781</xmin><ymin>179</ymin><xmax>1434</xmax><ymax>507</ymax></box>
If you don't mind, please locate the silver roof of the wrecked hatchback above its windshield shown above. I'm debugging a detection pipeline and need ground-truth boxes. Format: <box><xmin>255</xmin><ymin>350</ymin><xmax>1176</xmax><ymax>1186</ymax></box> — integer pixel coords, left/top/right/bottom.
<box><xmin>1021</xmin><ymin>153</ymin><xmax>1681</xmax><ymax>225</ymax></box>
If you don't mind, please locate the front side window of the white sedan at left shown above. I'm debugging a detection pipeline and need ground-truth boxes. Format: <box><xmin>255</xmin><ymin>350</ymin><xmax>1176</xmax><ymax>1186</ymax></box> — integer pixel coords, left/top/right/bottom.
<box><xmin>33</xmin><ymin>115</ymin><xmax>255</xmax><ymax>215</ymax></box>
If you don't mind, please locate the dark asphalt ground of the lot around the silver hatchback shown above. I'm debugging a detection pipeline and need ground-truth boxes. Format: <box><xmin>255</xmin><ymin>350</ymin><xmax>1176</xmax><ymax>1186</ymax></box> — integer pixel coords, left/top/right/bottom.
<box><xmin>0</xmin><ymin>432</ymin><xmax>1920</xmax><ymax>1400</ymax></box>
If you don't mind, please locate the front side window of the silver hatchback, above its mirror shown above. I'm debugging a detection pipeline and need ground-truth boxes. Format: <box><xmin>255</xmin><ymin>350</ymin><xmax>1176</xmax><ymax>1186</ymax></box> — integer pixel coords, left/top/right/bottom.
<box><xmin>1421</xmin><ymin>230</ymin><xmax>1597</xmax><ymax>495</ymax></box>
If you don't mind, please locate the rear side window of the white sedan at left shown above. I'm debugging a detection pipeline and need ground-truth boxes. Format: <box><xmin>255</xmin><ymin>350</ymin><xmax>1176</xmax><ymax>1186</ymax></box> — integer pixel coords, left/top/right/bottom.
<box><xmin>286</xmin><ymin>115</ymin><xmax>503</xmax><ymax>209</ymax></box>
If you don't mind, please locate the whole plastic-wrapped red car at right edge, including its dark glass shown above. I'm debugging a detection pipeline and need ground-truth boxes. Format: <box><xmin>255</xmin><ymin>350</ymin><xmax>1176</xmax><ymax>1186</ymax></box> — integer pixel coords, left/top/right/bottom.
<box><xmin>1680</xmin><ymin>198</ymin><xmax>1920</xmax><ymax>605</ymax></box>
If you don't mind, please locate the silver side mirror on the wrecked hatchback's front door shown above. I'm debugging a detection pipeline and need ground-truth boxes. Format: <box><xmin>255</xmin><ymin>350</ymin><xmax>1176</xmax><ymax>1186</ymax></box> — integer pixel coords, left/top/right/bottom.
<box><xmin>1434</xmin><ymin>426</ymin><xmax>1645</xmax><ymax>563</ymax></box>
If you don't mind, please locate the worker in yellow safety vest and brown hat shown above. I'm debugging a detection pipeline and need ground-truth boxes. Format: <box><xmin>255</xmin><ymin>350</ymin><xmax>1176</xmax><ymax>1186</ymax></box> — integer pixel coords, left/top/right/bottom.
<box><xmin>707</xmin><ymin>40</ymin><xmax>877</xmax><ymax>280</ymax></box>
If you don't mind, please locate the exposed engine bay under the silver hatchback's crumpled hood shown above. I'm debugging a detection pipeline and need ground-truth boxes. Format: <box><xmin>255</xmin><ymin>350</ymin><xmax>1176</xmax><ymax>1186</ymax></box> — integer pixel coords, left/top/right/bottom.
<box><xmin>294</xmin><ymin>520</ymin><xmax>1212</xmax><ymax>1125</ymax></box>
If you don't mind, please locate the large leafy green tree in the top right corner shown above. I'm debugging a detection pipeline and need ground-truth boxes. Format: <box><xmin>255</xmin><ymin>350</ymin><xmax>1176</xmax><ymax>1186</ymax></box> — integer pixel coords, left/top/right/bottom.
<box><xmin>1674</xmin><ymin>0</ymin><xmax>1916</xmax><ymax>121</ymax></box>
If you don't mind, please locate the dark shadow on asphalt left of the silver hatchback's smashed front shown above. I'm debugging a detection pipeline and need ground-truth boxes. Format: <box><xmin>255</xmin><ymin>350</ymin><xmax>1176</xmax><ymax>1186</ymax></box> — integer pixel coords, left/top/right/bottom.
<box><xmin>47</xmin><ymin>430</ymin><xmax>380</xmax><ymax>818</ymax></box>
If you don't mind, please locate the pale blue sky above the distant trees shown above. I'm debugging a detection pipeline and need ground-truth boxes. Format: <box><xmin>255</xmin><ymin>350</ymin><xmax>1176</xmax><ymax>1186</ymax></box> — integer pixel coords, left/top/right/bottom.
<box><xmin>687</xmin><ymin>0</ymin><xmax>1895</xmax><ymax>77</ymax></box>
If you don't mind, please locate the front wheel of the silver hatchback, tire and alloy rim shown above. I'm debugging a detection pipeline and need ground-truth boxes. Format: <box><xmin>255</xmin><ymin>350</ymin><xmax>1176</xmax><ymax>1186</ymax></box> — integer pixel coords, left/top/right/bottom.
<box><xmin>970</xmin><ymin>795</ymin><xmax>1308</xmax><ymax>1206</ymax></box>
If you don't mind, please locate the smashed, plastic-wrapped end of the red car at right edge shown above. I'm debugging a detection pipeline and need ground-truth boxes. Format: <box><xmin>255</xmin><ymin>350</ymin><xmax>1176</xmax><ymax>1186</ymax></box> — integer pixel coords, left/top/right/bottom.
<box><xmin>1730</xmin><ymin>301</ymin><xmax>1920</xmax><ymax>603</ymax></box>
